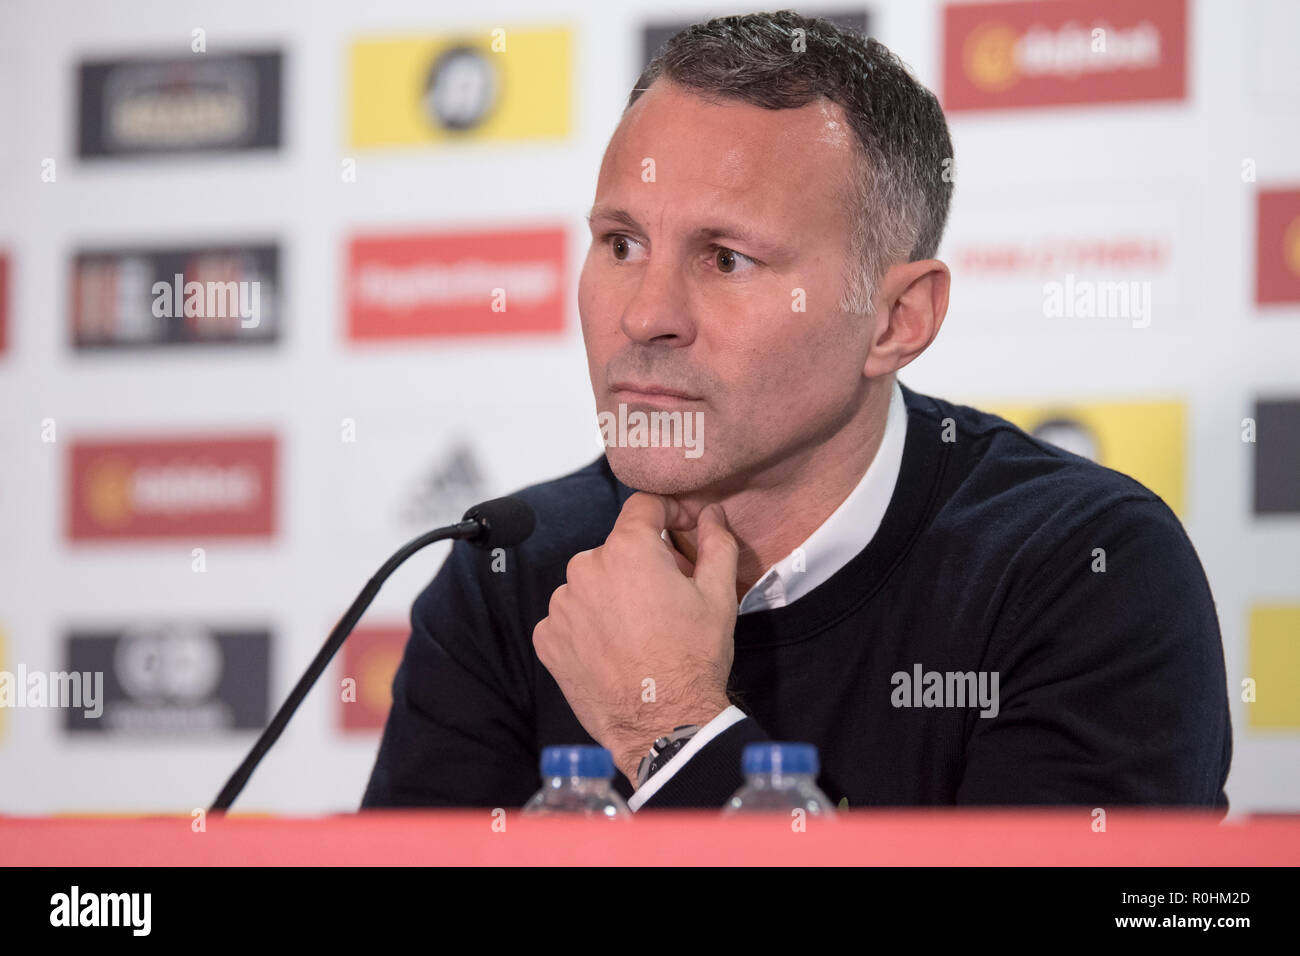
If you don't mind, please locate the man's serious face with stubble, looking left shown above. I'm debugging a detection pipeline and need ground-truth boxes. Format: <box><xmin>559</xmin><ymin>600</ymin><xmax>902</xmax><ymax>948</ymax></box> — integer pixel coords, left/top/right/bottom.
<box><xmin>579</xmin><ymin>79</ymin><xmax>872</xmax><ymax>496</ymax></box>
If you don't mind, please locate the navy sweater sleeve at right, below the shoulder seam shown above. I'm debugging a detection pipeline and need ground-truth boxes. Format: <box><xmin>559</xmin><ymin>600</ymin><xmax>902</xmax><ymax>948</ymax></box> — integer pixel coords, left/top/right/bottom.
<box><xmin>957</xmin><ymin>498</ymin><xmax>1232</xmax><ymax>810</ymax></box>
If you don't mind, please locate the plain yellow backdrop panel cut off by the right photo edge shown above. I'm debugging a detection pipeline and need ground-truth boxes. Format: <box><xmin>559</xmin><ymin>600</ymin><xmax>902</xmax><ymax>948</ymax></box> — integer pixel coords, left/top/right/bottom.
<box><xmin>1244</xmin><ymin>605</ymin><xmax>1300</xmax><ymax>730</ymax></box>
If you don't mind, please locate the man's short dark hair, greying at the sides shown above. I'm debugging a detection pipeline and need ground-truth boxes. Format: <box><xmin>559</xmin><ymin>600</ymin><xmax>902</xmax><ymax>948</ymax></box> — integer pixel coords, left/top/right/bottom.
<box><xmin>628</xmin><ymin>10</ymin><xmax>953</xmax><ymax>312</ymax></box>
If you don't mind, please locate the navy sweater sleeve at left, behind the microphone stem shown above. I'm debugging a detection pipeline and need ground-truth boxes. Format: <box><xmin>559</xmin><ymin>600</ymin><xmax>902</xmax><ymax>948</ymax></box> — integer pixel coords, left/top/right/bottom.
<box><xmin>361</xmin><ymin>542</ymin><xmax>540</xmax><ymax>809</ymax></box>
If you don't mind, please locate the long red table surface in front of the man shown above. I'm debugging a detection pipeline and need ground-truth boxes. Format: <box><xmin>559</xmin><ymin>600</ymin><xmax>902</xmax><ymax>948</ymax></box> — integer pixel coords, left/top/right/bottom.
<box><xmin>0</xmin><ymin>808</ymin><xmax>1300</xmax><ymax>866</ymax></box>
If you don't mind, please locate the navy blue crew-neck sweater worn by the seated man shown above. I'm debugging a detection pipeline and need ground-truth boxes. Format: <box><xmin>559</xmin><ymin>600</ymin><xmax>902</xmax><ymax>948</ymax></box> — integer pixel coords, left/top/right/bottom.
<box><xmin>361</xmin><ymin>388</ymin><xmax>1232</xmax><ymax>813</ymax></box>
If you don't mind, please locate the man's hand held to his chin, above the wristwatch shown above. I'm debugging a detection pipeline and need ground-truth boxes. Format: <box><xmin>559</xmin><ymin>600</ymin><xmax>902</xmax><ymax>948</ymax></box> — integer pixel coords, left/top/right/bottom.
<box><xmin>533</xmin><ymin>492</ymin><xmax>738</xmax><ymax>784</ymax></box>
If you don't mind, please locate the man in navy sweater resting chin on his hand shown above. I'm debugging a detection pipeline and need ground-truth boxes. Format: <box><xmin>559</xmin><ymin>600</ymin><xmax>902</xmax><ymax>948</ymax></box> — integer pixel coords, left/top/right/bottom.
<box><xmin>363</xmin><ymin>13</ymin><xmax>1231</xmax><ymax>810</ymax></box>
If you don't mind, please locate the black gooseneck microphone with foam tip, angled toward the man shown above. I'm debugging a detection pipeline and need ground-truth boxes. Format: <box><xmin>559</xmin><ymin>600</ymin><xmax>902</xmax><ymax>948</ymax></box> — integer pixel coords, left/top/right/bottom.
<box><xmin>211</xmin><ymin>497</ymin><xmax>537</xmax><ymax>813</ymax></box>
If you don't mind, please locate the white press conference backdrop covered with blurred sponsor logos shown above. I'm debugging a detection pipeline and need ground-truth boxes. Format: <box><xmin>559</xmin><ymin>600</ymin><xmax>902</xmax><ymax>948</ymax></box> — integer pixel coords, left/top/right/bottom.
<box><xmin>0</xmin><ymin>0</ymin><xmax>1300</xmax><ymax>813</ymax></box>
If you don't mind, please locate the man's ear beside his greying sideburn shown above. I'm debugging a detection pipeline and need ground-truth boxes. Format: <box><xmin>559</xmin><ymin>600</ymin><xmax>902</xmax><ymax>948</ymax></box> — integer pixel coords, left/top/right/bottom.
<box><xmin>862</xmin><ymin>259</ymin><xmax>952</xmax><ymax>378</ymax></box>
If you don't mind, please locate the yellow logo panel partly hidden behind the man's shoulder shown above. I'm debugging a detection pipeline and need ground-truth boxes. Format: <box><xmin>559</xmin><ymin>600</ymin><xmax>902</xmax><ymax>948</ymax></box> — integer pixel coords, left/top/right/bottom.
<box><xmin>980</xmin><ymin>402</ymin><xmax>1187</xmax><ymax>518</ymax></box>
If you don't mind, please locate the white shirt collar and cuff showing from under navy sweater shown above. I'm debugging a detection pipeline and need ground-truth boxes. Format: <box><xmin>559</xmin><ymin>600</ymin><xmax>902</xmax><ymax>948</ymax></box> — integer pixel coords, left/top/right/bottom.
<box><xmin>628</xmin><ymin>378</ymin><xmax>907</xmax><ymax>810</ymax></box>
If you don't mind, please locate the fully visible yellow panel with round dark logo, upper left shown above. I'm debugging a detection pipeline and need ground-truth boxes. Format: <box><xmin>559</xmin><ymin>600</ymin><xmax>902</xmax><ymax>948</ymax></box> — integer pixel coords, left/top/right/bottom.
<box><xmin>348</xmin><ymin>27</ymin><xmax>572</xmax><ymax>148</ymax></box>
